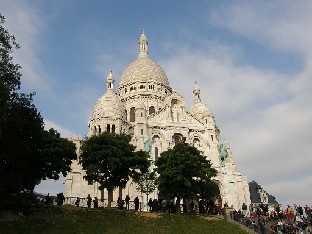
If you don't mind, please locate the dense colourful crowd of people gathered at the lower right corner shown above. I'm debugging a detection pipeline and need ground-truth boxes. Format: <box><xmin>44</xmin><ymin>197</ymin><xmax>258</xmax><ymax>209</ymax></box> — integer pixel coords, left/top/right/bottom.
<box><xmin>231</xmin><ymin>203</ymin><xmax>312</xmax><ymax>234</ymax></box>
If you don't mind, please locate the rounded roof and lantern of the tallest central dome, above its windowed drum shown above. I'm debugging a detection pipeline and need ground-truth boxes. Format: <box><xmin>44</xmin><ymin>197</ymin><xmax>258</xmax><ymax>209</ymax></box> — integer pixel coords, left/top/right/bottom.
<box><xmin>119</xmin><ymin>32</ymin><xmax>169</xmax><ymax>87</ymax></box>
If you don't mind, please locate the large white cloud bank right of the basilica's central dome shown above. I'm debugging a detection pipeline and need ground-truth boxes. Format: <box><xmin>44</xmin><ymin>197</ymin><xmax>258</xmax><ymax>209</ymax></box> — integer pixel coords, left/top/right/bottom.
<box><xmin>163</xmin><ymin>35</ymin><xmax>312</xmax><ymax>204</ymax></box>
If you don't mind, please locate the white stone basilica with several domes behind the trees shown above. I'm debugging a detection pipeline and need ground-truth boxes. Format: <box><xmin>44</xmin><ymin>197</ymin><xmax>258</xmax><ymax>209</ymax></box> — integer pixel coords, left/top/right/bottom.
<box><xmin>64</xmin><ymin>32</ymin><xmax>250</xmax><ymax>209</ymax></box>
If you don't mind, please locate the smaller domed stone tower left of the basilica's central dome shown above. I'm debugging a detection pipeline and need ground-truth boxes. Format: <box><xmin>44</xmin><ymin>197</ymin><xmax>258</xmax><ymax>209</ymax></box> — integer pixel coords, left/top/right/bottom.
<box><xmin>88</xmin><ymin>70</ymin><xmax>127</xmax><ymax>136</ymax></box>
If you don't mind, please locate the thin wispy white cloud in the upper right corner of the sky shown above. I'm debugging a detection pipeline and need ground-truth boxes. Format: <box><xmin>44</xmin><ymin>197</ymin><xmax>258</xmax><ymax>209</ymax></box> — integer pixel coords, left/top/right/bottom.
<box><xmin>209</xmin><ymin>0</ymin><xmax>312</xmax><ymax>56</ymax></box>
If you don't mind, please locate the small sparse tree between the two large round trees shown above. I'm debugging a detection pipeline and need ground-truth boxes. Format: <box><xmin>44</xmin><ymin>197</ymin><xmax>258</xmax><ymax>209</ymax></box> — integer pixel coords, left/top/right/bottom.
<box><xmin>134</xmin><ymin>169</ymin><xmax>157</xmax><ymax>205</ymax></box>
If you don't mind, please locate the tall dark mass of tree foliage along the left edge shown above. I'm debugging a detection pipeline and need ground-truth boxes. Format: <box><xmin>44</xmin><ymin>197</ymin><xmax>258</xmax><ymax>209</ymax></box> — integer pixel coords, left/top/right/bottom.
<box><xmin>0</xmin><ymin>14</ymin><xmax>75</xmax><ymax>212</ymax></box>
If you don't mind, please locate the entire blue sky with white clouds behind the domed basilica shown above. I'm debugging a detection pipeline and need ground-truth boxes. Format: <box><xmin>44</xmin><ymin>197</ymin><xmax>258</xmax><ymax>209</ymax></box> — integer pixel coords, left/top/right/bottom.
<box><xmin>0</xmin><ymin>0</ymin><xmax>312</xmax><ymax>208</ymax></box>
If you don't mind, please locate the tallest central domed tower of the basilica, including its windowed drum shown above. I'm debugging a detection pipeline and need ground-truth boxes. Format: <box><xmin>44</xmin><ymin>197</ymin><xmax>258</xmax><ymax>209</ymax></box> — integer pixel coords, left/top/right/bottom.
<box><xmin>116</xmin><ymin>30</ymin><xmax>172</xmax><ymax>124</ymax></box>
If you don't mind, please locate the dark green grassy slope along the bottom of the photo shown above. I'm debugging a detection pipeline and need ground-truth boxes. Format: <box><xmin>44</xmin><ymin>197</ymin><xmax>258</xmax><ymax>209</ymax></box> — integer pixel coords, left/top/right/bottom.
<box><xmin>0</xmin><ymin>207</ymin><xmax>245</xmax><ymax>234</ymax></box>
